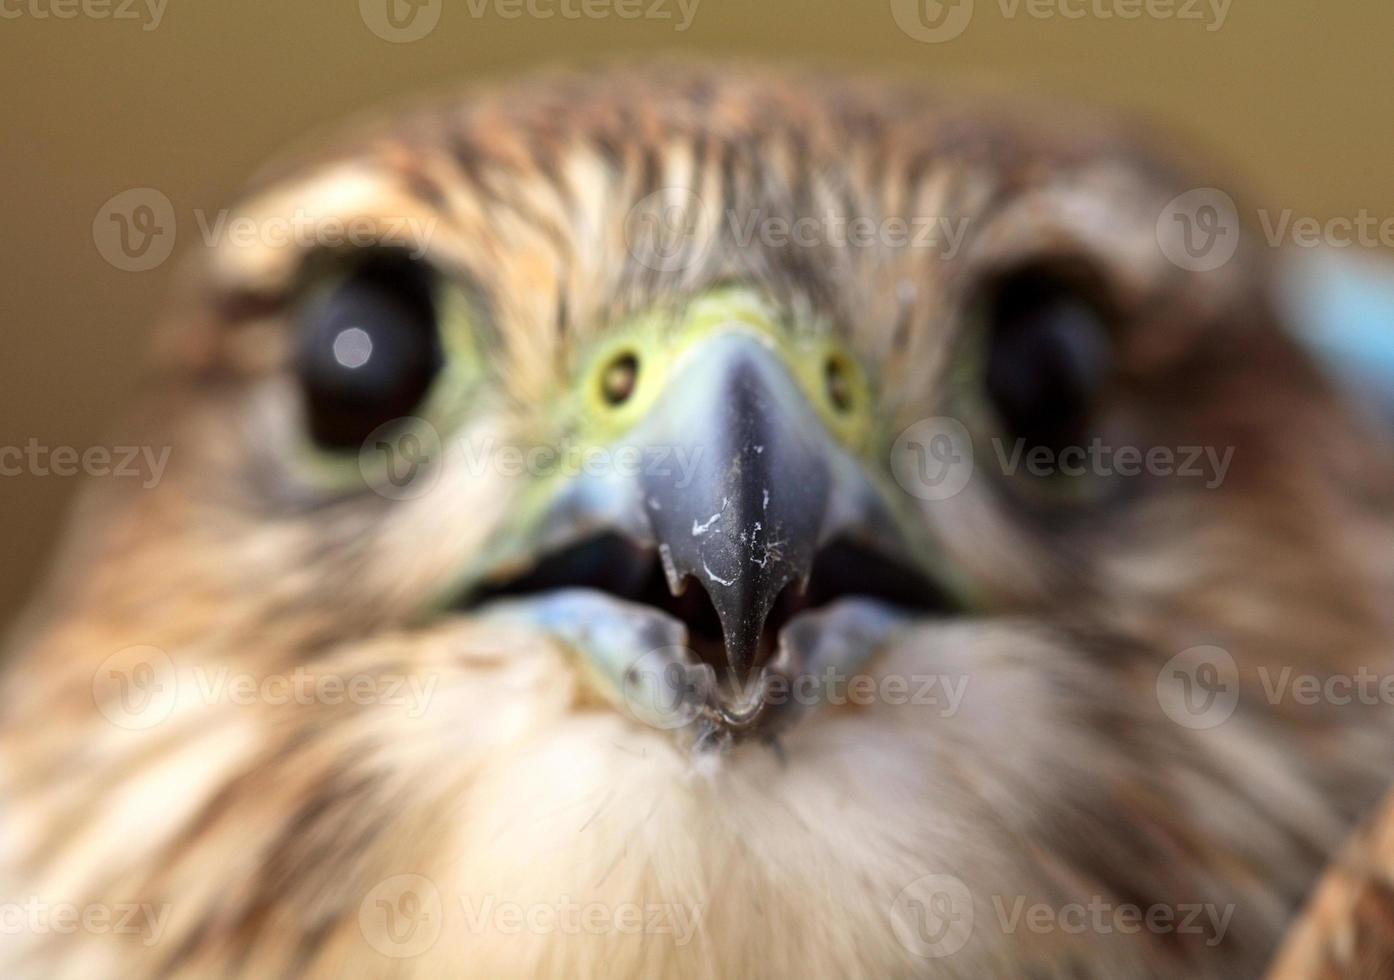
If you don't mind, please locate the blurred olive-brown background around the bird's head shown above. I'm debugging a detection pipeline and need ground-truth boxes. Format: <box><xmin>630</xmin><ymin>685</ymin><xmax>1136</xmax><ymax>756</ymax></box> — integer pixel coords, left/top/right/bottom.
<box><xmin>0</xmin><ymin>0</ymin><xmax>1394</xmax><ymax>619</ymax></box>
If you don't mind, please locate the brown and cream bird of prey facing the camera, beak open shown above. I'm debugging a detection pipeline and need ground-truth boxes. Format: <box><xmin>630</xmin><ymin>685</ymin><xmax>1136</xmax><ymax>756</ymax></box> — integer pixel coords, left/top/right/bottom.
<box><xmin>0</xmin><ymin>63</ymin><xmax>1394</xmax><ymax>980</ymax></box>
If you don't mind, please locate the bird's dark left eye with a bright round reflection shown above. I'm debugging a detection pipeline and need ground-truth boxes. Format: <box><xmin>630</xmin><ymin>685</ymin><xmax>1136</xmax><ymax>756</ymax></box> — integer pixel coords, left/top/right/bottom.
<box><xmin>296</xmin><ymin>255</ymin><xmax>442</xmax><ymax>450</ymax></box>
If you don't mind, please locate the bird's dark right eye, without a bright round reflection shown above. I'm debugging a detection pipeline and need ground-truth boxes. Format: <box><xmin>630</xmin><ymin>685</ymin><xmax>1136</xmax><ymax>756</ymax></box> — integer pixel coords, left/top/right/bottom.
<box><xmin>983</xmin><ymin>269</ymin><xmax>1112</xmax><ymax>450</ymax></box>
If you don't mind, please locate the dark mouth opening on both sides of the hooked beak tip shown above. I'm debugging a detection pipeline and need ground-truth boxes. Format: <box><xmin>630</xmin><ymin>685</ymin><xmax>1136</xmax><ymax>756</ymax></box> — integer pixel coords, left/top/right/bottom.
<box><xmin>463</xmin><ymin>534</ymin><xmax>960</xmax><ymax>675</ymax></box>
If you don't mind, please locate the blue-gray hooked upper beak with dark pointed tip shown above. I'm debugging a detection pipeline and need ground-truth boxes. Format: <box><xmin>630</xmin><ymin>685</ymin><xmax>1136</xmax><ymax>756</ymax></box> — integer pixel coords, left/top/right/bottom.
<box><xmin>643</xmin><ymin>332</ymin><xmax>889</xmax><ymax>682</ymax></box>
